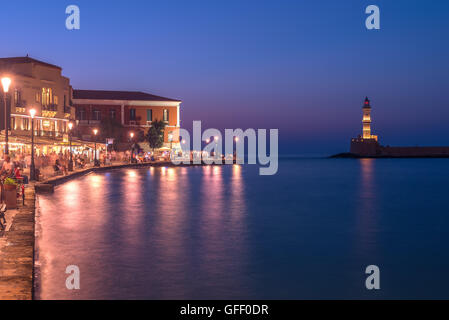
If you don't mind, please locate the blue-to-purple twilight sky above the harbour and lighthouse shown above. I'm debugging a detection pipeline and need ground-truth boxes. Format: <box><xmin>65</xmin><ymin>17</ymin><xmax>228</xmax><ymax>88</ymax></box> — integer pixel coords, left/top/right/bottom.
<box><xmin>0</xmin><ymin>0</ymin><xmax>449</xmax><ymax>154</ymax></box>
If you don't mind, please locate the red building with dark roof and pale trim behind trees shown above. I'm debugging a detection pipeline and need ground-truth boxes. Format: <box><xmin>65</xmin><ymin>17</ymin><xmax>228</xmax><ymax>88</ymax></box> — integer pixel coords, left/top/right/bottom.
<box><xmin>73</xmin><ymin>90</ymin><xmax>181</xmax><ymax>148</ymax></box>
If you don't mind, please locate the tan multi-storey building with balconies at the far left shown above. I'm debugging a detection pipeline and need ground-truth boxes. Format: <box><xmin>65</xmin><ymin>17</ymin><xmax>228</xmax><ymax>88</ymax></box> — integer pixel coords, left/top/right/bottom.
<box><xmin>0</xmin><ymin>56</ymin><xmax>75</xmax><ymax>140</ymax></box>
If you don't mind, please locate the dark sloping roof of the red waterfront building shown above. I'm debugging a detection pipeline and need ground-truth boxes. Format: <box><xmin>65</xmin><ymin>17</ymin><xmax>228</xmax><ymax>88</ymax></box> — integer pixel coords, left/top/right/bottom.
<box><xmin>73</xmin><ymin>90</ymin><xmax>181</xmax><ymax>102</ymax></box>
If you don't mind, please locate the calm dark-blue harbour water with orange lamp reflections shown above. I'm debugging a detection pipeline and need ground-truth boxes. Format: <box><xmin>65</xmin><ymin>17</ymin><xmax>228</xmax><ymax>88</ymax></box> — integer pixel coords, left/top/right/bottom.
<box><xmin>35</xmin><ymin>159</ymin><xmax>449</xmax><ymax>299</ymax></box>
